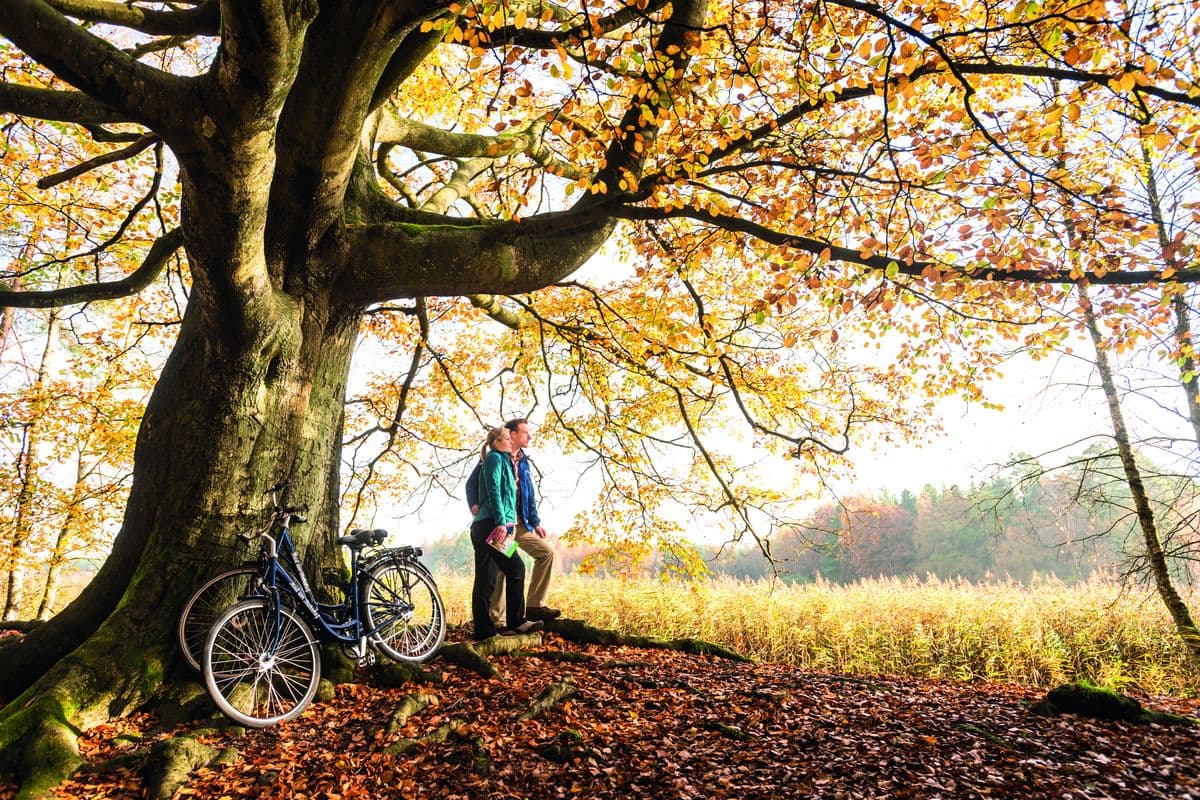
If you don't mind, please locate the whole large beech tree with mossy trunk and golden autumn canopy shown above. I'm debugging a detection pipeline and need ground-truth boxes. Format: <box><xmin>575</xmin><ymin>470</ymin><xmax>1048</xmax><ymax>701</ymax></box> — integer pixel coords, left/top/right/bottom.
<box><xmin>0</xmin><ymin>0</ymin><xmax>1200</xmax><ymax>792</ymax></box>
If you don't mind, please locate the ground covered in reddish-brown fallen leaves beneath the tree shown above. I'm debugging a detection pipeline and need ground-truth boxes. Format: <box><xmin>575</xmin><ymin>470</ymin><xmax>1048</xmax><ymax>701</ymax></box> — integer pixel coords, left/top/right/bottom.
<box><xmin>0</xmin><ymin>634</ymin><xmax>1200</xmax><ymax>800</ymax></box>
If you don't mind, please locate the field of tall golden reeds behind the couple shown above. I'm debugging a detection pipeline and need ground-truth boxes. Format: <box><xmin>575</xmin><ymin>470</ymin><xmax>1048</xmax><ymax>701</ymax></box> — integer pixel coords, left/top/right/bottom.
<box><xmin>438</xmin><ymin>575</ymin><xmax>1200</xmax><ymax>697</ymax></box>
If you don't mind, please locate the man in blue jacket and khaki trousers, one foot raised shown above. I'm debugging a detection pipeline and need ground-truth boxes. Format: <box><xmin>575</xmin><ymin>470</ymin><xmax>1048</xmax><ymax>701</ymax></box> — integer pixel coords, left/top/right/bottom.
<box><xmin>491</xmin><ymin>417</ymin><xmax>562</xmax><ymax>621</ymax></box>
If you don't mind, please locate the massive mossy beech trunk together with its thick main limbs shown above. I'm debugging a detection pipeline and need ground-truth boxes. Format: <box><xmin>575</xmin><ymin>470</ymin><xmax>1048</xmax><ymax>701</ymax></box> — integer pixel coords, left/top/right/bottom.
<box><xmin>0</xmin><ymin>0</ymin><xmax>604</xmax><ymax>794</ymax></box>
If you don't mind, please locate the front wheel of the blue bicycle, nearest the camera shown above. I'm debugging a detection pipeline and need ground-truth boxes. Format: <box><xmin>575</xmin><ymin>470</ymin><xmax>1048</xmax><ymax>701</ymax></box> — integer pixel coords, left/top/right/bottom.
<box><xmin>203</xmin><ymin>600</ymin><xmax>320</xmax><ymax>728</ymax></box>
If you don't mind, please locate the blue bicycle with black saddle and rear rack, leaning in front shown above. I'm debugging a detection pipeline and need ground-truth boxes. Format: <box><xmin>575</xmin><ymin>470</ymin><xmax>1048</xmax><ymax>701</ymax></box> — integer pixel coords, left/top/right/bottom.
<box><xmin>201</xmin><ymin>487</ymin><xmax>446</xmax><ymax>728</ymax></box>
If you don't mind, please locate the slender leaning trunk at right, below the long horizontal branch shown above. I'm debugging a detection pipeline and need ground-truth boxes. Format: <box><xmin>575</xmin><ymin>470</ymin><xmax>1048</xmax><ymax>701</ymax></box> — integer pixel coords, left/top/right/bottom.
<box><xmin>1079</xmin><ymin>287</ymin><xmax>1200</xmax><ymax>667</ymax></box>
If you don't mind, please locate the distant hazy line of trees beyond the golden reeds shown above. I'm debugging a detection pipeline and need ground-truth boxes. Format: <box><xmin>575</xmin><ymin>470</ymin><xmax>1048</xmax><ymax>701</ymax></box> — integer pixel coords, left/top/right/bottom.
<box><xmin>426</xmin><ymin>449</ymin><xmax>1200</xmax><ymax>583</ymax></box>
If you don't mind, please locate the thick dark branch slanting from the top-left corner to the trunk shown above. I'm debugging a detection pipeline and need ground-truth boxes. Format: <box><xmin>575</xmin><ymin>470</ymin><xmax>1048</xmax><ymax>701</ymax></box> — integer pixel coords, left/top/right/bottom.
<box><xmin>0</xmin><ymin>0</ymin><xmax>193</xmax><ymax>137</ymax></box>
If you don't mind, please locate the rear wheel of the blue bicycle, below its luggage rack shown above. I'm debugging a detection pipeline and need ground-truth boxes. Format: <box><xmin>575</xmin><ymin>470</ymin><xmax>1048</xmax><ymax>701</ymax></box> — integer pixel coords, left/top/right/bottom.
<box><xmin>360</xmin><ymin>559</ymin><xmax>446</xmax><ymax>662</ymax></box>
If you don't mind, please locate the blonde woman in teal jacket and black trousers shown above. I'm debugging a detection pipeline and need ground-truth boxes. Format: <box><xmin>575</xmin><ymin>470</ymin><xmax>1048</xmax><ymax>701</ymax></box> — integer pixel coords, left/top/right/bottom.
<box><xmin>470</xmin><ymin>427</ymin><xmax>541</xmax><ymax>640</ymax></box>
